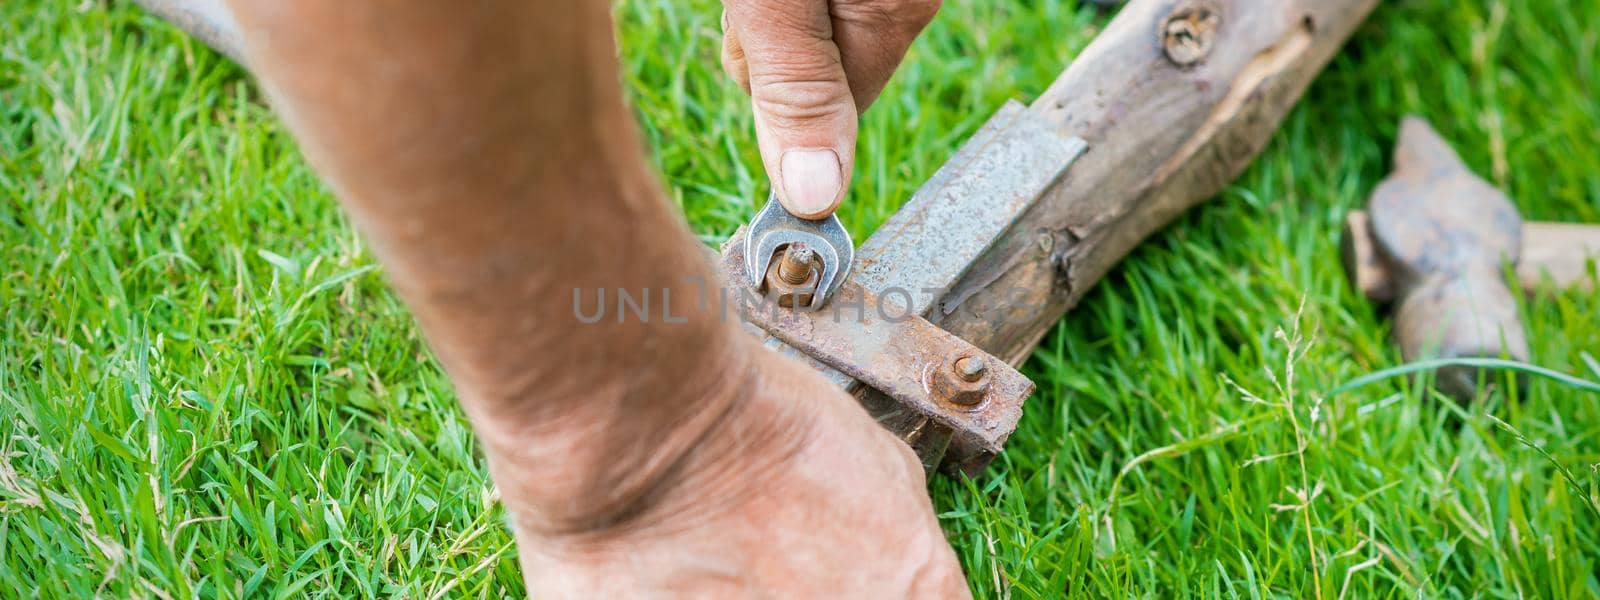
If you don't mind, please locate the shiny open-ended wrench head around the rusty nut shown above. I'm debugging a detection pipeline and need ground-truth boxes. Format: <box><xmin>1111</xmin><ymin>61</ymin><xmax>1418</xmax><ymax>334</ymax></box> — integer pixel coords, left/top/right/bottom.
<box><xmin>744</xmin><ymin>192</ymin><xmax>856</xmax><ymax>309</ymax></box>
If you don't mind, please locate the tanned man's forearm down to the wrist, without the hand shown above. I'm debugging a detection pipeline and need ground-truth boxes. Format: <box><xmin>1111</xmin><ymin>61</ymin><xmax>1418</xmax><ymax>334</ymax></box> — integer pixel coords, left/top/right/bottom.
<box><xmin>224</xmin><ymin>0</ymin><xmax>774</xmax><ymax>531</ymax></box>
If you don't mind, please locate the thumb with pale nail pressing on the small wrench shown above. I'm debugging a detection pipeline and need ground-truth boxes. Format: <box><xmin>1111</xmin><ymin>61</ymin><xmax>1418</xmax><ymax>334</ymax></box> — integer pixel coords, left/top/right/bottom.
<box><xmin>726</xmin><ymin>0</ymin><xmax>856</xmax><ymax>219</ymax></box>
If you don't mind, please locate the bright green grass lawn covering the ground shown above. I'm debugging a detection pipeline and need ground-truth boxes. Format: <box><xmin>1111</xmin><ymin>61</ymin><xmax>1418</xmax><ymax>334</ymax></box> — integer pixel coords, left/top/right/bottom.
<box><xmin>0</xmin><ymin>0</ymin><xmax>1600</xmax><ymax>598</ymax></box>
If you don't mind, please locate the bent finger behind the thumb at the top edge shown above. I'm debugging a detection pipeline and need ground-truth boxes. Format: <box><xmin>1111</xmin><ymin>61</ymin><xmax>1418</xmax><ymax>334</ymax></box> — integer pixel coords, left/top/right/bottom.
<box><xmin>832</xmin><ymin>0</ymin><xmax>941</xmax><ymax>110</ymax></box>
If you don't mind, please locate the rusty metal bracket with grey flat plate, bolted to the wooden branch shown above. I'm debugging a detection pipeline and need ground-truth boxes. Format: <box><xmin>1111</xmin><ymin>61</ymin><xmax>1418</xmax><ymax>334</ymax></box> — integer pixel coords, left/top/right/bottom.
<box><xmin>722</xmin><ymin>101</ymin><xmax>1088</xmax><ymax>472</ymax></box>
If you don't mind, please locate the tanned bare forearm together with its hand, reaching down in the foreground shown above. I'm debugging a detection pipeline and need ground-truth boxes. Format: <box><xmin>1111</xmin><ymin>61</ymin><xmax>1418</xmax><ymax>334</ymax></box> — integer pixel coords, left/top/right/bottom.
<box><xmin>224</xmin><ymin>0</ymin><xmax>968</xmax><ymax>598</ymax></box>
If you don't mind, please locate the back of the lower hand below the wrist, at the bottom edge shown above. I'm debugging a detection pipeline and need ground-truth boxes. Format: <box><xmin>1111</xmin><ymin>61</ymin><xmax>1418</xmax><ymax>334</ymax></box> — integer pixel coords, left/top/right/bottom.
<box><xmin>518</xmin><ymin>339</ymin><xmax>970</xmax><ymax>598</ymax></box>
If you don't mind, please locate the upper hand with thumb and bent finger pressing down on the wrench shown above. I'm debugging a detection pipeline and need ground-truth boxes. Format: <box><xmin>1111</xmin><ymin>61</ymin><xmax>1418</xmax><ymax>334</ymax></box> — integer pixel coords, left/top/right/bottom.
<box><xmin>722</xmin><ymin>0</ymin><xmax>941</xmax><ymax>219</ymax></box>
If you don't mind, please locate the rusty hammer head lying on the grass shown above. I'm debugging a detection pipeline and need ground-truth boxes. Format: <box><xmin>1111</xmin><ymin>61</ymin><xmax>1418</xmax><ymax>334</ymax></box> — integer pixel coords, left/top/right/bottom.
<box><xmin>1342</xmin><ymin>117</ymin><xmax>1528</xmax><ymax>398</ymax></box>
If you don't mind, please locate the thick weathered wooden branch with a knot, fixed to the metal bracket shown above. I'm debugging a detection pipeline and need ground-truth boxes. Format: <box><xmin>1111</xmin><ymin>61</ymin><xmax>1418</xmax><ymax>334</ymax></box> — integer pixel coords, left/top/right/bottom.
<box><xmin>931</xmin><ymin>0</ymin><xmax>1378</xmax><ymax>363</ymax></box>
